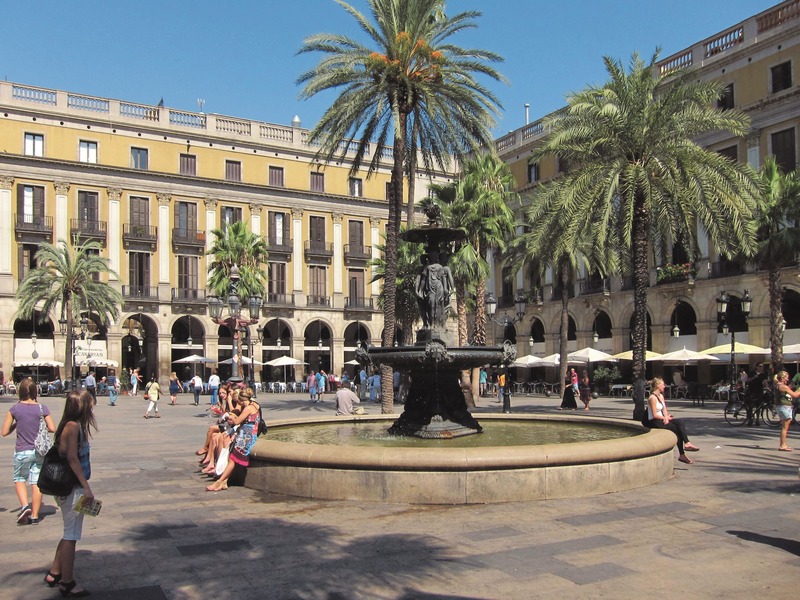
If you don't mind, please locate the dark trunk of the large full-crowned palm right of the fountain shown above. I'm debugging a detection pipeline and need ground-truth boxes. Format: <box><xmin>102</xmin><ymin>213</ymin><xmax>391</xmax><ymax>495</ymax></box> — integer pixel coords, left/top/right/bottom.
<box><xmin>631</xmin><ymin>192</ymin><xmax>650</xmax><ymax>421</ymax></box>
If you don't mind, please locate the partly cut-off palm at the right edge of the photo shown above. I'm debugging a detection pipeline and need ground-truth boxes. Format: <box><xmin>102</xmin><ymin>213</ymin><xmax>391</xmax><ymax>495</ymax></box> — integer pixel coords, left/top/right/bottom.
<box><xmin>756</xmin><ymin>156</ymin><xmax>800</xmax><ymax>373</ymax></box>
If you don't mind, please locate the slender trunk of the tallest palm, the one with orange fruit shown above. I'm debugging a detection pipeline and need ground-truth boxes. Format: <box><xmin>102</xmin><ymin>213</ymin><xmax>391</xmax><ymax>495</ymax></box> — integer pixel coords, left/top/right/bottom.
<box><xmin>381</xmin><ymin>112</ymin><xmax>407</xmax><ymax>414</ymax></box>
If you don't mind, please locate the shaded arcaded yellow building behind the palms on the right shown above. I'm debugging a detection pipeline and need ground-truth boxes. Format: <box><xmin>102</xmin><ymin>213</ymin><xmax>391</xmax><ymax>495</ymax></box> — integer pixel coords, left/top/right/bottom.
<box><xmin>488</xmin><ymin>0</ymin><xmax>800</xmax><ymax>382</ymax></box>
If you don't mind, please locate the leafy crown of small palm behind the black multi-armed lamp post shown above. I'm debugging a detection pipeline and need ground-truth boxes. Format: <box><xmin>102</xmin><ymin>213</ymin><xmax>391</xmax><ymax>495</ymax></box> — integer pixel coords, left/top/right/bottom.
<box><xmin>206</xmin><ymin>221</ymin><xmax>269</xmax><ymax>298</ymax></box>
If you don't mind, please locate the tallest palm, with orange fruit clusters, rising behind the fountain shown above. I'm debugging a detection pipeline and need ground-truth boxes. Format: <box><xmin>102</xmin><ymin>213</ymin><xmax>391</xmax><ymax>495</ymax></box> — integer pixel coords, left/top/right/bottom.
<box><xmin>298</xmin><ymin>0</ymin><xmax>502</xmax><ymax>413</ymax></box>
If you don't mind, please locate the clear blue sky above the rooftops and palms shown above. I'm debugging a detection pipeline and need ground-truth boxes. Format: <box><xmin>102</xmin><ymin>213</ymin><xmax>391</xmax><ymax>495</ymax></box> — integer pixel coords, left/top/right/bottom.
<box><xmin>0</xmin><ymin>0</ymin><xmax>777</xmax><ymax>136</ymax></box>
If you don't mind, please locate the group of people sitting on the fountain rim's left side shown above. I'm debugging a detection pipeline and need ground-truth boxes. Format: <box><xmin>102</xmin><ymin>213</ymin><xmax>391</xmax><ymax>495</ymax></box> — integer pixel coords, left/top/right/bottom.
<box><xmin>195</xmin><ymin>384</ymin><xmax>262</xmax><ymax>492</ymax></box>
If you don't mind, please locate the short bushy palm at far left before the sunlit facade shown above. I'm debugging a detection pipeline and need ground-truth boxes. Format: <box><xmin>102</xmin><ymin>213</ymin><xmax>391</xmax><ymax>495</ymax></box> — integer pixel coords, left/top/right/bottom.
<box><xmin>17</xmin><ymin>240</ymin><xmax>122</xmax><ymax>386</ymax></box>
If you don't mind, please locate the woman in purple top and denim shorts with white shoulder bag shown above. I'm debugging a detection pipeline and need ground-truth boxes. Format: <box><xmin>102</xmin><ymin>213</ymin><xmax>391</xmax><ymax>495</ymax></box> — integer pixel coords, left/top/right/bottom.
<box><xmin>2</xmin><ymin>378</ymin><xmax>56</xmax><ymax>525</ymax></box>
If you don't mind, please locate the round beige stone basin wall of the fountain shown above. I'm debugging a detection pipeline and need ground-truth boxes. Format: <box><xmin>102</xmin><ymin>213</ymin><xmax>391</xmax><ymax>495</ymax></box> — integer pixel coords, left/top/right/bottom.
<box><xmin>245</xmin><ymin>414</ymin><xmax>676</xmax><ymax>504</ymax></box>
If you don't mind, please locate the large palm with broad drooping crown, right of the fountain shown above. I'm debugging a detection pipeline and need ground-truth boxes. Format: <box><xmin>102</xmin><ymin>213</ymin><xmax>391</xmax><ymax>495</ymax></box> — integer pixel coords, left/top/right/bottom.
<box><xmin>531</xmin><ymin>51</ymin><xmax>757</xmax><ymax>418</ymax></box>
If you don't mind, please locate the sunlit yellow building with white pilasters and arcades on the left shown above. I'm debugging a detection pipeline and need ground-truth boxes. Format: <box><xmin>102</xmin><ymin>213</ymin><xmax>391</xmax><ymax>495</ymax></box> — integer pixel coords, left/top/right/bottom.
<box><xmin>0</xmin><ymin>82</ymin><xmax>449</xmax><ymax>381</ymax></box>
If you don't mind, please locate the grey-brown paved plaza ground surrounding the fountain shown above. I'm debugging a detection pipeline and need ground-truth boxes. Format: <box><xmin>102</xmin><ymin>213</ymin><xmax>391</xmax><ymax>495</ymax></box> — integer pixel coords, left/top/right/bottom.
<box><xmin>0</xmin><ymin>386</ymin><xmax>800</xmax><ymax>600</ymax></box>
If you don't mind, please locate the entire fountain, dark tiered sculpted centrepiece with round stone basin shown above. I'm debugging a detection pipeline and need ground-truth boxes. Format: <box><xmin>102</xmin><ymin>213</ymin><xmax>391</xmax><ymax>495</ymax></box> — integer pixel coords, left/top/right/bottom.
<box><xmin>246</xmin><ymin>210</ymin><xmax>675</xmax><ymax>504</ymax></box>
